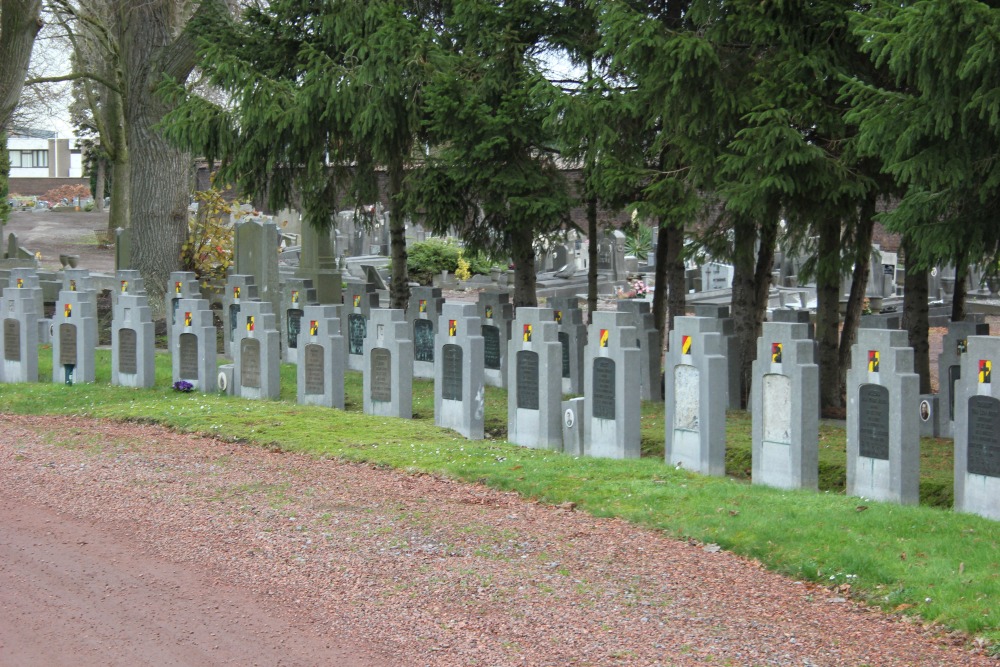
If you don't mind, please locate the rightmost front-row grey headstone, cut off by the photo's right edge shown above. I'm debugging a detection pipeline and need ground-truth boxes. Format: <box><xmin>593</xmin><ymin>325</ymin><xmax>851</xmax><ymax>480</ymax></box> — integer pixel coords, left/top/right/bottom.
<box><xmin>954</xmin><ymin>336</ymin><xmax>1000</xmax><ymax>520</ymax></box>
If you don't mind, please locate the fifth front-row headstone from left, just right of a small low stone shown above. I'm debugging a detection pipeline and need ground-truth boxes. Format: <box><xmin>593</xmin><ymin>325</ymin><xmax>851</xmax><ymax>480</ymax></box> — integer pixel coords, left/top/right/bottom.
<box><xmin>233</xmin><ymin>301</ymin><xmax>281</xmax><ymax>400</ymax></box>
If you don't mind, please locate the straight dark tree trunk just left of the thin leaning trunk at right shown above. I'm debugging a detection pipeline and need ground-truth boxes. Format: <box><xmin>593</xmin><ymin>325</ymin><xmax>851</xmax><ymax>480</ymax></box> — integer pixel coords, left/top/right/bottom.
<box><xmin>816</xmin><ymin>215</ymin><xmax>844</xmax><ymax>410</ymax></box>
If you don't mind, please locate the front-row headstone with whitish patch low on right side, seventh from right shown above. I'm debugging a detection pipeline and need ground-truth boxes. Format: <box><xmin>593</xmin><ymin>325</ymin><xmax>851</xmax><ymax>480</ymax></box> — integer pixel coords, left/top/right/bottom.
<box><xmin>434</xmin><ymin>303</ymin><xmax>485</xmax><ymax>440</ymax></box>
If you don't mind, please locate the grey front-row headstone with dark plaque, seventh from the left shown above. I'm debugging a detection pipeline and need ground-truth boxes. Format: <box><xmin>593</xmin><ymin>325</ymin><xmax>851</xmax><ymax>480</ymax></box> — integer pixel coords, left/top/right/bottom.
<box><xmin>363</xmin><ymin>308</ymin><xmax>413</xmax><ymax>419</ymax></box>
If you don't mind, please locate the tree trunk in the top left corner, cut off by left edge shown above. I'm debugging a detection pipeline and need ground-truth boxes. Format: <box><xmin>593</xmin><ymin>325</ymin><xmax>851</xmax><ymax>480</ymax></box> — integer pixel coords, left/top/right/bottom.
<box><xmin>0</xmin><ymin>0</ymin><xmax>42</xmax><ymax>132</ymax></box>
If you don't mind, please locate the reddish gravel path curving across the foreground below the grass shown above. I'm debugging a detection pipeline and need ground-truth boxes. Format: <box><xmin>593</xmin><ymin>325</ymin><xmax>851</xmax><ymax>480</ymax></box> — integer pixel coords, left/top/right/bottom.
<box><xmin>0</xmin><ymin>415</ymin><xmax>997</xmax><ymax>667</ymax></box>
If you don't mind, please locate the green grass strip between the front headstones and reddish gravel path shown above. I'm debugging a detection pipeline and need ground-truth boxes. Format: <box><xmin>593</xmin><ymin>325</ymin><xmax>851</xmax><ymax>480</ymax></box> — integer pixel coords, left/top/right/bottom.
<box><xmin>0</xmin><ymin>347</ymin><xmax>1000</xmax><ymax>653</ymax></box>
